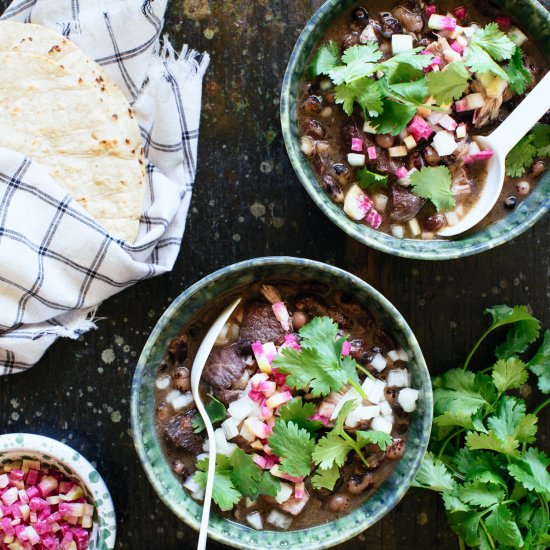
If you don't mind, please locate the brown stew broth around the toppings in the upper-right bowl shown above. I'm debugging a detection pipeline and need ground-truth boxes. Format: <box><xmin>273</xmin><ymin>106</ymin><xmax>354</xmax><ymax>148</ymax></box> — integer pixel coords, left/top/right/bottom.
<box><xmin>297</xmin><ymin>0</ymin><xmax>548</xmax><ymax>239</ymax></box>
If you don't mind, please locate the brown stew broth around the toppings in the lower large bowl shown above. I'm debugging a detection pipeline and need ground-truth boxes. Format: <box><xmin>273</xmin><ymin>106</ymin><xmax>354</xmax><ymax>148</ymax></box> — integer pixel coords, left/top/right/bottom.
<box><xmin>155</xmin><ymin>279</ymin><xmax>410</xmax><ymax>530</ymax></box>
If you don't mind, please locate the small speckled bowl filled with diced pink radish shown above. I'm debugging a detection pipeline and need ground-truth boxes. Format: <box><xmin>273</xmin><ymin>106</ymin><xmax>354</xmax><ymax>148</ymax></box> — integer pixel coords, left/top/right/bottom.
<box><xmin>0</xmin><ymin>433</ymin><xmax>116</xmax><ymax>550</ymax></box>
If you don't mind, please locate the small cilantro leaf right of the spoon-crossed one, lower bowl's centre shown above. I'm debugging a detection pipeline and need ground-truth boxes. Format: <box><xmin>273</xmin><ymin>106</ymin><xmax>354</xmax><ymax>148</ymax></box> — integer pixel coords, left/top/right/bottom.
<box><xmin>268</xmin><ymin>419</ymin><xmax>315</xmax><ymax>477</ymax></box>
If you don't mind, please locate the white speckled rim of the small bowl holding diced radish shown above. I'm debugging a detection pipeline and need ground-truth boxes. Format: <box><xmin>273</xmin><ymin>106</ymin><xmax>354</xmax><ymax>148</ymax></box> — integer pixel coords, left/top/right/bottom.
<box><xmin>0</xmin><ymin>433</ymin><xmax>116</xmax><ymax>550</ymax></box>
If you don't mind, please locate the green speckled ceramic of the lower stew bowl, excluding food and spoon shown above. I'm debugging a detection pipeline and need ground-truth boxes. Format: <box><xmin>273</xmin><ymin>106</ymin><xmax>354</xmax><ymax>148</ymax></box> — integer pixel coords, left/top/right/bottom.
<box><xmin>131</xmin><ymin>257</ymin><xmax>432</xmax><ymax>550</ymax></box>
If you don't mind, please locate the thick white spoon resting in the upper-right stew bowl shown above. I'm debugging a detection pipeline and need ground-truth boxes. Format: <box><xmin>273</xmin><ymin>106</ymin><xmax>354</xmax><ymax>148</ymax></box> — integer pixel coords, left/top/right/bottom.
<box><xmin>438</xmin><ymin>72</ymin><xmax>550</xmax><ymax>237</ymax></box>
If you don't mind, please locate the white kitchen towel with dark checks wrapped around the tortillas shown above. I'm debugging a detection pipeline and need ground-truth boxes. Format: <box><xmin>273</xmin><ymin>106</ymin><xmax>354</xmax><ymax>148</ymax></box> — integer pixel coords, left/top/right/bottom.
<box><xmin>0</xmin><ymin>0</ymin><xmax>209</xmax><ymax>374</ymax></box>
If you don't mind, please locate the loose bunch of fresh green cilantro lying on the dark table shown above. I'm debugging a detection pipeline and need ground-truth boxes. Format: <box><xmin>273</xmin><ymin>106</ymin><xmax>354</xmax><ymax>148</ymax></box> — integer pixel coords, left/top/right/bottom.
<box><xmin>415</xmin><ymin>306</ymin><xmax>550</xmax><ymax>550</ymax></box>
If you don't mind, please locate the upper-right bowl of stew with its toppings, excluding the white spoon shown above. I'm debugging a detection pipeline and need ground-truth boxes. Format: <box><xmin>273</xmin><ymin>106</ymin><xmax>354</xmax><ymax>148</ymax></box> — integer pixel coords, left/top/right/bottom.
<box><xmin>281</xmin><ymin>0</ymin><xmax>550</xmax><ymax>260</ymax></box>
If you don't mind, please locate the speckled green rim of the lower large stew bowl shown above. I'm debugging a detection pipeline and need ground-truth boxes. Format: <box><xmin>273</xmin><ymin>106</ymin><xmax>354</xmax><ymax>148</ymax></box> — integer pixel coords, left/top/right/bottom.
<box><xmin>130</xmin><ymin>256</ymin><xmax>433</xmax><ymax>550</ymax></box>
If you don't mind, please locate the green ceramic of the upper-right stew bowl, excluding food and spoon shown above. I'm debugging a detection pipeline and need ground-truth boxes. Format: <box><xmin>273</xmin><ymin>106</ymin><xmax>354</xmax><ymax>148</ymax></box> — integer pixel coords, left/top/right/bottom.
<box><xmin>281</xmin><ymin>0</ymin><xmax>550</xmax><ymax>260</ymax></box>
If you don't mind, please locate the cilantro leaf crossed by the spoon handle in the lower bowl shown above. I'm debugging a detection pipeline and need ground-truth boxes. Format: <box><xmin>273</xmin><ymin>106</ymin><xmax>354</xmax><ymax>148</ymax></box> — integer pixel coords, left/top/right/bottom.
<box><xmin>194</xmin><ymin>447</ymin><xmax>281</xmax><ymax>511</ymax></box>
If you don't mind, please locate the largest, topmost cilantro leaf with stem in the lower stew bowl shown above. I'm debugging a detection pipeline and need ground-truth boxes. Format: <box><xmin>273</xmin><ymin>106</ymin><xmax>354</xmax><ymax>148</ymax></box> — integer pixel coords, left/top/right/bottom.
<box><xmin>273</xmin><ymin>317</ymin><xmax>366</xmax><ymax>399</ymax></box>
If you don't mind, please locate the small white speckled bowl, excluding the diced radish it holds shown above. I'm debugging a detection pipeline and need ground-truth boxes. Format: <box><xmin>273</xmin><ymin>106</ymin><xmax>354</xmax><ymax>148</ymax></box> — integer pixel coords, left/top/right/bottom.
<box><xmin>0</xmin><ymin>433</ymin><xmax>116</xmax><ymax>550</ymax></box>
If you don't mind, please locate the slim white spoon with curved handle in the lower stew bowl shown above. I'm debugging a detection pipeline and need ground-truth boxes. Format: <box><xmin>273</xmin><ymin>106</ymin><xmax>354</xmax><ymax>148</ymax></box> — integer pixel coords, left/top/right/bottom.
<box><xmin>191</xmin><ymin>298</ymin><xmax>241</xmax><ymax>550</ymax></box>
